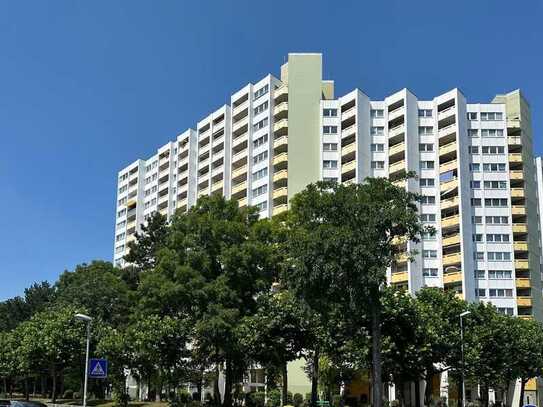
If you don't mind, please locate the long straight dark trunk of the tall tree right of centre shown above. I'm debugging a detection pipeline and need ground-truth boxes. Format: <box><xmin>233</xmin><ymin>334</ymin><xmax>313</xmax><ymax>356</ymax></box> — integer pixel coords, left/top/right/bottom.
<box><xmin>370</xmin><ymin>287</ymin><xmax>383</xmax><ymax>407</ymax></box>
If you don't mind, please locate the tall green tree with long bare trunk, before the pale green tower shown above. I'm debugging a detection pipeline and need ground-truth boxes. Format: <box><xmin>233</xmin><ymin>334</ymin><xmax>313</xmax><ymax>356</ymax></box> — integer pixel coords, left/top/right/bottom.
<box><xmin>287</xmin><ymin>182</ymin><xmax>422</xmax><ymax>406</ymax></box>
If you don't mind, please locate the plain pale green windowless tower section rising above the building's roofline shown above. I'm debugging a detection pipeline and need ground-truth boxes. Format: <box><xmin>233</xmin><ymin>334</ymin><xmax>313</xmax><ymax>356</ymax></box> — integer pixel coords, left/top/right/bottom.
<box><xmin>281</xmin><ymin>54</ymin><xmax>323</xmax><ymax>200</ymax></box>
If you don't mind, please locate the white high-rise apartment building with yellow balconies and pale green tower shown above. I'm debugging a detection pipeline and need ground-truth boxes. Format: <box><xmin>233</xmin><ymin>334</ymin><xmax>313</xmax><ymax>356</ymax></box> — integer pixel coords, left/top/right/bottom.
<box><xmin>114</xmin><ymin>54</ymin><xmax>542</xmax><ymax>319</ymax></box>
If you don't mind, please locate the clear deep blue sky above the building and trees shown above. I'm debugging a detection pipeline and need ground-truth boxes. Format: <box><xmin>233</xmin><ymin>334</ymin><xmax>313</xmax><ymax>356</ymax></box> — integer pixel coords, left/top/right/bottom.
<box><xmin>0</xmin><ymin>0</ymin><xmax>543</xmax><ymax>300</ymax></box>
